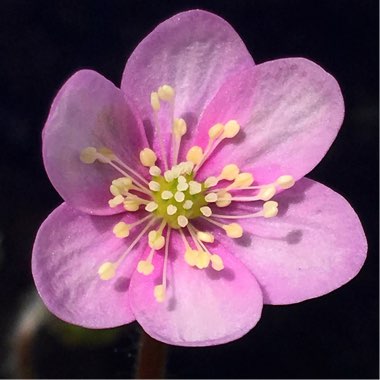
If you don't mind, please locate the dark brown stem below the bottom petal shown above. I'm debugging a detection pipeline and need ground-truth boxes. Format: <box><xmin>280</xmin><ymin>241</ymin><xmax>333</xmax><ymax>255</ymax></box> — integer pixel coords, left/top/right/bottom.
<box><xmin>135</xmin><ymin>331</ymin><xmax>166</xmax><ymax>379</ymax></box>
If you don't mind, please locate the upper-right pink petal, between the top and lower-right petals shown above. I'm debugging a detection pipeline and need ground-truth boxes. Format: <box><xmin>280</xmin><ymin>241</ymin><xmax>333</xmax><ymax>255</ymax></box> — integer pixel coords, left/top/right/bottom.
<box><xmin>196</xmin><ymin>58</ymin><xmax>344</xmax><ymax>183</ymax></box>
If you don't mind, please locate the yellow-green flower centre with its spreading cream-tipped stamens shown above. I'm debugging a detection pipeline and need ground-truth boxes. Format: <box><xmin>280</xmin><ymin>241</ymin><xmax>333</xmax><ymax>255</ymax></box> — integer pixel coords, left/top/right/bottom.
<box><xmin>80</xmin><ymin>85</ymin><xmax>294</xmax><ymax>302</ymax></box>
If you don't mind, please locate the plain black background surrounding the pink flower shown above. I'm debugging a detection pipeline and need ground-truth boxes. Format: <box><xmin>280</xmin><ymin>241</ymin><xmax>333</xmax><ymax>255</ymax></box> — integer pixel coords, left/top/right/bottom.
<box><xmin>0</xmin><ymin>0</ymin><xmax>379</xmax><ymax>378</ymax></box>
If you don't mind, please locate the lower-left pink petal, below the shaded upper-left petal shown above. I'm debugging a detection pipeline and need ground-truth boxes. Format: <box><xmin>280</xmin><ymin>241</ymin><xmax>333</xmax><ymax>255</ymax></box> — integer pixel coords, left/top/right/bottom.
<box><xmin>32</xmin><ymin>203</ymin><xmax>143</xmax><ymax>328</ymax></box>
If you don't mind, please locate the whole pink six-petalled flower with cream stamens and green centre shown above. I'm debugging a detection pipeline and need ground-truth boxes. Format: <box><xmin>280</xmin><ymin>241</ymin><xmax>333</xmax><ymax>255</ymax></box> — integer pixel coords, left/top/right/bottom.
<box><xmin>32</xmin><ymin>10</ymin><xmax>367</xmax><ymax>346</ymax></box>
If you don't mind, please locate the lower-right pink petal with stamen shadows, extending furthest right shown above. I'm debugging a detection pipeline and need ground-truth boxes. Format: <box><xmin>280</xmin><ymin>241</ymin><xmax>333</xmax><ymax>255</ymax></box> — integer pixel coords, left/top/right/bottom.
<box><xmin>220</xmin><ymin>178</ymin><xmax>367</xmax><ymax>304</ymax></box>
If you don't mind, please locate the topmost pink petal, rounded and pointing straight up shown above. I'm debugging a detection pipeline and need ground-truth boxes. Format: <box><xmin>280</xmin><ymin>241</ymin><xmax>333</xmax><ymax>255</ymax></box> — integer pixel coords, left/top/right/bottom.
<box><xmin>121</xmin><ymin>10</ymin><xmax>253</xmax><ymax>165</ymax></box>
